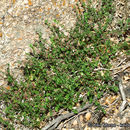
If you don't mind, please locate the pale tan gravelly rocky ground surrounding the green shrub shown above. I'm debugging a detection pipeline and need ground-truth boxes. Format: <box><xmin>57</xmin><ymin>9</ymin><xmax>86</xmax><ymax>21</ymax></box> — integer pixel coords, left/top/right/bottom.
<box><xmin>0</xmin><ymin>0</ymin><xmax>130</xmax><ymax>130</ymax></box>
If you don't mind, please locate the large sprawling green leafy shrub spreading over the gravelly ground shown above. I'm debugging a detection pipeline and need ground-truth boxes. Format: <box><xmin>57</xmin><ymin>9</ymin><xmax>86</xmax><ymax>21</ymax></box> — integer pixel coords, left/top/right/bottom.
<box><xmin>0</xmin><ymin>0</ymin><xmax>126</xmax><ymax>127</ymax></box>
